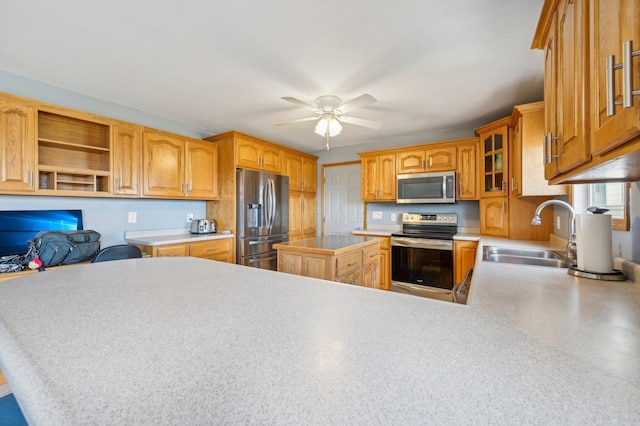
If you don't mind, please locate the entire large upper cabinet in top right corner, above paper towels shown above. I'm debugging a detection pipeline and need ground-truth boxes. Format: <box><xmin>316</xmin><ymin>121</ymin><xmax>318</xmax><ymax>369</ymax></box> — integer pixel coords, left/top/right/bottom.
<box><xmin>532</xmin><ymin>0</ymin><xmax>640</xmax><ymax>184</ymax></box>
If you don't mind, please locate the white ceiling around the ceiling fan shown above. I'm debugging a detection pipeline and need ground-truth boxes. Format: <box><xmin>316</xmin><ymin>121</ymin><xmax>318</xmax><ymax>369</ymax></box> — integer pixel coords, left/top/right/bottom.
<box><xmin>0</xmin><ymin>0</ymin><xmax>543</xmax><ymax>151</ymax></box>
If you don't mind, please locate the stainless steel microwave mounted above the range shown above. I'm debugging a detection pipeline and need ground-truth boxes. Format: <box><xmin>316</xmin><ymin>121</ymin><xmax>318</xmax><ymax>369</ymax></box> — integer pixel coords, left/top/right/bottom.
<box><xmin>397</xmin><ymin>171</ymin><xmax>456</xmax><ymax>204</ymax></box>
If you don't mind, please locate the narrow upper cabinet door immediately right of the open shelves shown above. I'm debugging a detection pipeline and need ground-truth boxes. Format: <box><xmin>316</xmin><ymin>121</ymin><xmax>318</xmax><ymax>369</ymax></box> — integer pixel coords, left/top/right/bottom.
<box><xmin>111</xmin><ymin>124</ymin><xmax>141</xmax><ymax>196</ymax></box>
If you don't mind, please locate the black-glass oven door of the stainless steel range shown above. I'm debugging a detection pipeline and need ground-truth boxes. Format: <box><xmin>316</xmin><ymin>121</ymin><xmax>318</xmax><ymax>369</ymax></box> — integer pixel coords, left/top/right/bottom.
<box><xmin>391</xmin><ymin>237</ymin><xmax>453</xmax><ymax>292</ymax></box>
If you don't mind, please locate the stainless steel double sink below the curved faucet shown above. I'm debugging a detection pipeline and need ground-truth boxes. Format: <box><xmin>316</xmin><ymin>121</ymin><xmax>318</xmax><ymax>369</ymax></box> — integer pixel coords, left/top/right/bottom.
<box><xmin>482</xmin><ymin>246</ymin><xmax>571</xmax><ymax>268</ymax></box>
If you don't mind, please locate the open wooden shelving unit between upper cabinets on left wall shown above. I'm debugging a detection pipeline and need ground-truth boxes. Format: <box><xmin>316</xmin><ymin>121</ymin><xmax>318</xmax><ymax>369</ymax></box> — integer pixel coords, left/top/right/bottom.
<box><xmin>38</xmin><ymin>111</ymin><xmax>111</xmax><ymax>194</ymax></box>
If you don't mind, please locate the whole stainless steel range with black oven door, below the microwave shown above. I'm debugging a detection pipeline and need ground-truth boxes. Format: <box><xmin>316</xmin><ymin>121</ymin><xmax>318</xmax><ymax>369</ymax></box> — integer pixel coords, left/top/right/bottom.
<box><xmin>391</xmin><ymin>213</ymin><xmax>458</xmax><ymax>301</ymax></box>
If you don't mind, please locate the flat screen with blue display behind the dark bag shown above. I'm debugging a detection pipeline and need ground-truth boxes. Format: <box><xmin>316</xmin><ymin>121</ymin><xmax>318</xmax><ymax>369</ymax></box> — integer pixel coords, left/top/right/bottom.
<box><xmin>0</xmin><ymin>210</ymin><xmax>83</xmax><ymax>258</ymax></box>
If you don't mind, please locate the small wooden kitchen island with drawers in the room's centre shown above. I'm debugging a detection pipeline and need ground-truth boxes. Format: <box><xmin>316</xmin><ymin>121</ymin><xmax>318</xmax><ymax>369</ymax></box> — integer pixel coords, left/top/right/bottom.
<box><xmin>273</xmin><ymin>235</ymin><xmax>381</xmax><ymax>288</ymax></box>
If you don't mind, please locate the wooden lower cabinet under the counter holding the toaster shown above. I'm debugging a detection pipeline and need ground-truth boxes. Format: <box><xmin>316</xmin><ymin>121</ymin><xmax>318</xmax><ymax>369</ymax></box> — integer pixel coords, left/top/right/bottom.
<box><xmin>137</xmin><ymin>238</ymin><xmax>234</xmax><ymax>263</ymax></box>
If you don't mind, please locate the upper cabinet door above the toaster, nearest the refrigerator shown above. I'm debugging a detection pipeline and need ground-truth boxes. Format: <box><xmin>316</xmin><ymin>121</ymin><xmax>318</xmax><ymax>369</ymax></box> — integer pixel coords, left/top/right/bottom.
<box><xmin>185</xmin><ymin>139</ymin><xmax>219</xmax><ymax>199</ymax></box>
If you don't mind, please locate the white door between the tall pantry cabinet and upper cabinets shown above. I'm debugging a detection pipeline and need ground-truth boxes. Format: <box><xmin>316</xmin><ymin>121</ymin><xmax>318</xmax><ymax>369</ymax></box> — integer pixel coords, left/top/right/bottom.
<box><xmin>324</xmin><ymin>163</ymin><xmax>364</xmax><ymax>235</ymax></box>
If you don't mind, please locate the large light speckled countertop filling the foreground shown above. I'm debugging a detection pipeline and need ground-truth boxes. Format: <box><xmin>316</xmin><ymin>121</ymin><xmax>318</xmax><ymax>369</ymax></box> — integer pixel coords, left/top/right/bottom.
<box><xmin>0</xmin><ymin>257</ymin><xmax>640</xmax><ymax>425</ymax></box>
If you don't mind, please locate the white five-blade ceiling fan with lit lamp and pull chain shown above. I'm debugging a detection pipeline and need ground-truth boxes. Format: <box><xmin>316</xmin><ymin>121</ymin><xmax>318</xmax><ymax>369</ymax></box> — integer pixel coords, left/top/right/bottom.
<box><xmin>276</xmin><ymin>93</ymin><xmax>382</xmax><ymax>150</ymax></box>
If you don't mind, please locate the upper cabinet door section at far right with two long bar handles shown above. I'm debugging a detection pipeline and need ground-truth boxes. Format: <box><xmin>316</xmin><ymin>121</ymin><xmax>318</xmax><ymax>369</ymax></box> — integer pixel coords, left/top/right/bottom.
<box><xmin>592</xmin><ymin>0</ymin><xmax>640</xmax><ymax>155</ymax></box>
